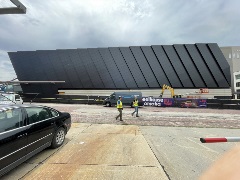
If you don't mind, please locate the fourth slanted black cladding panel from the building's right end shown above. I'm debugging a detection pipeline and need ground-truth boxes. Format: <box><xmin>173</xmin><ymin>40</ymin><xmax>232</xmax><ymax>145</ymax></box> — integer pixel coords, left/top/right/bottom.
<box><xmin>173</xmin><ymin>45</ymin><xmax>206</xmax><ymax>88</ymax></box>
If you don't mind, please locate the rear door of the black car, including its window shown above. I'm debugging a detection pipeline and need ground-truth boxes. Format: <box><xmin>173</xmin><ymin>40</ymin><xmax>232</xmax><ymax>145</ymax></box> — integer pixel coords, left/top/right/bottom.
<box><xmin>25</xmin><ymin>107</ymin><xmax>55</xmax><ymax>154</ymax></box>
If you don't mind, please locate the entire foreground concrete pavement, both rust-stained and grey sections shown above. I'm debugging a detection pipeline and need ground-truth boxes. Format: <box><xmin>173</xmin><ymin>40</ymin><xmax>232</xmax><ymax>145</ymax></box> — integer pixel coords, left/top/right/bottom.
<box><xmin>2</xmin><ymin>123</ymin><xmax>238</xmax><ymax>180</ymax></box>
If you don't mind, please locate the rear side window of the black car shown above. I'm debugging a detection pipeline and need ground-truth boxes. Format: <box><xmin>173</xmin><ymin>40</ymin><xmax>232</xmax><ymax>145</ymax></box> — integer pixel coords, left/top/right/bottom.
<box><xmin>26</xmin><ymin>107</ymin><xmax>51</xmax><ymax>124</ymax></box>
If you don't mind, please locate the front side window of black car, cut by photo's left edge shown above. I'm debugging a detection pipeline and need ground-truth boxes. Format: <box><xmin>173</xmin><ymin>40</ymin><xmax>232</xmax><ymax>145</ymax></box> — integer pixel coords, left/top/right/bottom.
<box><xmin>0</xmin><ymin>108</ymin><xmax>23</xmax><ymax>133</ymax></box>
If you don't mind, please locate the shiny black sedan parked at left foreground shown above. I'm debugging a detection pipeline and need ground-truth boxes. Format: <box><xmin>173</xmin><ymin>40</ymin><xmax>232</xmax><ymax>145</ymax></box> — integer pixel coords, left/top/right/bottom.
<box><xmin>0</xmin><ymin>104</ymin><xmax>71</xmax><ymax>176</ymax></box>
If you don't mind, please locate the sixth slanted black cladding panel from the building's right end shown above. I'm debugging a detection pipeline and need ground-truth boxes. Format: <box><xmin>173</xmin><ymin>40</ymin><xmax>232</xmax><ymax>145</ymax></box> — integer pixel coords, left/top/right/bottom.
<box><xmin>152</xmin><ymin>45</ymin><xmax>183</xmax><ymax>88</ymax></box>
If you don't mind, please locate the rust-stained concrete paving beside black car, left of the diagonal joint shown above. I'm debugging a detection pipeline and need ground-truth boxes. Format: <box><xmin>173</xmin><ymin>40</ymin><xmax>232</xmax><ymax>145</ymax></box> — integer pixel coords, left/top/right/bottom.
<box><xmin>2</xmin><ymin>123</ymin><xmax>168</xmax><ymax>180</ymax></box>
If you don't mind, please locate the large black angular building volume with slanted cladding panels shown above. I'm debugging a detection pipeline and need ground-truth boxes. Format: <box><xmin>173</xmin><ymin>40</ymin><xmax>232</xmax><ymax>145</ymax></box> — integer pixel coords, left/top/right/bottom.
<box><xmin>8</xmin><ymin>43</ymin><xmax>231</xmax><ymax>94</ymax></box>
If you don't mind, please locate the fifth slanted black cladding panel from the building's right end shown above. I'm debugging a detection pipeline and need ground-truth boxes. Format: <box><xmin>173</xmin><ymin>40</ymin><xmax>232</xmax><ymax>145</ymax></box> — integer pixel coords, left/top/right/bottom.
<box><xmin>163</xmin><ymin>45</ymin><xmax>194</xmax><ymax>88</ymax></box>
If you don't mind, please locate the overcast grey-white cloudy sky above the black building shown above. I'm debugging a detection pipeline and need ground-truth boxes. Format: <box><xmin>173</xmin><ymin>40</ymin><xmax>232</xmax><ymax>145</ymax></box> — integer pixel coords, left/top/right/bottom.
<box><xmin>0</xmin><ymin>0</ymin><xmax>240</xmax><ymax>80</ymax></box>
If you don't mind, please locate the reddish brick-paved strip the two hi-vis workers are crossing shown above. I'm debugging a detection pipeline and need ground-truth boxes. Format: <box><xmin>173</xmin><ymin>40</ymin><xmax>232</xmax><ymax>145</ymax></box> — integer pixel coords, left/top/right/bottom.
<box><xmin>47</xmin><ymin>104</ymin><xmax>240</xmax><ymax>128</ymax></box>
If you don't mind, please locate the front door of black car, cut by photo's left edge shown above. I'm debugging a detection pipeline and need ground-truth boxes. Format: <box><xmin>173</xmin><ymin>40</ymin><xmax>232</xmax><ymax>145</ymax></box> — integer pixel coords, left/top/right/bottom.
<box><xmin>0</xmin><ymin>108</ymin><xmax>27</xmax><ymax>175</ymax></box>
